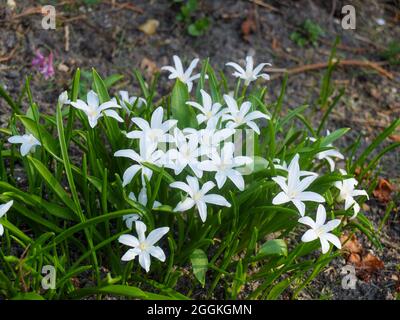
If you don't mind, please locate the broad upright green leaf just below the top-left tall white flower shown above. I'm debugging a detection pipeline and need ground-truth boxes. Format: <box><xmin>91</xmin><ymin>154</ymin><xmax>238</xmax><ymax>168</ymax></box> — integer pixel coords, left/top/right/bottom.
<box><xmin>171</xmin><ymin>79</ymin><xmax>197</xmax><ymax>129</ymax></box>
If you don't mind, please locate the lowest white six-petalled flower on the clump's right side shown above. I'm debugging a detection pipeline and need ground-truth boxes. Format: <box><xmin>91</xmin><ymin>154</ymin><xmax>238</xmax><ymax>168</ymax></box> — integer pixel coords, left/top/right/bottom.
<box><xmin>298</xmin><ymin>204</ymin><xmax>342</xmax><ymax>253</ymax></box>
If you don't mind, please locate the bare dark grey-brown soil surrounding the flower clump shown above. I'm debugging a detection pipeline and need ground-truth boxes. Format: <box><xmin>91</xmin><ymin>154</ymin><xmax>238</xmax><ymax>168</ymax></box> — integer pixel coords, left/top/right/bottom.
<box><xmin>0</xmin><ymin>0</ymin><xmax>400</xmax><ymax>299</ymax></box>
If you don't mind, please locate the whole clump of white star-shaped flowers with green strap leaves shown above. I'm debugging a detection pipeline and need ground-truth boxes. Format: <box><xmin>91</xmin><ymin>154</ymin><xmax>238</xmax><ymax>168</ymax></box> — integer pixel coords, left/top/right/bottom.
<box><xmin>0</xmin><ymin>56</ymin><xmax>399</xmax><ymax>299</ymax></box>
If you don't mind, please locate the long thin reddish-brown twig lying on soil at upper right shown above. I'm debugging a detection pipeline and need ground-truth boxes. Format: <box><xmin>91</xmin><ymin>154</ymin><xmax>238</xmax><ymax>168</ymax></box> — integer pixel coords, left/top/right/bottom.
<box><xmin>271</xmin><ymin>60</ymin><xmax>394</xmax><ymax>80</ymax></box>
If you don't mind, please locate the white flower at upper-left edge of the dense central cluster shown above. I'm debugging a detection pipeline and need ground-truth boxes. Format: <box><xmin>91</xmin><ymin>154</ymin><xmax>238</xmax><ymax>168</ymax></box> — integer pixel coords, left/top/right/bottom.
<box><xmin>126</xmin><ymin>107</ymin><xmax>178</xmax><ymax>144</ymax></box>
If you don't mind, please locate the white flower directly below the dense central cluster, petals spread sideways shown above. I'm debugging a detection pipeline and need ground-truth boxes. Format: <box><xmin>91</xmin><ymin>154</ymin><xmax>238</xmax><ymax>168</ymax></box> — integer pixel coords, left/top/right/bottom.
<box><xmin>170</xmin><ymin>176</ymin><xmax>231</xmax><ymax>222</ymax></box>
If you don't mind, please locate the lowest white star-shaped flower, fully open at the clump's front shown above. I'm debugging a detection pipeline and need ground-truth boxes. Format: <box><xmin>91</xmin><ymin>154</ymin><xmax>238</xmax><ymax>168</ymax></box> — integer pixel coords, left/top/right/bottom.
<box><xmin>118</xmin><ymin>221</ymin><xmax>169</xmax><ymax>272</ymax></box>
